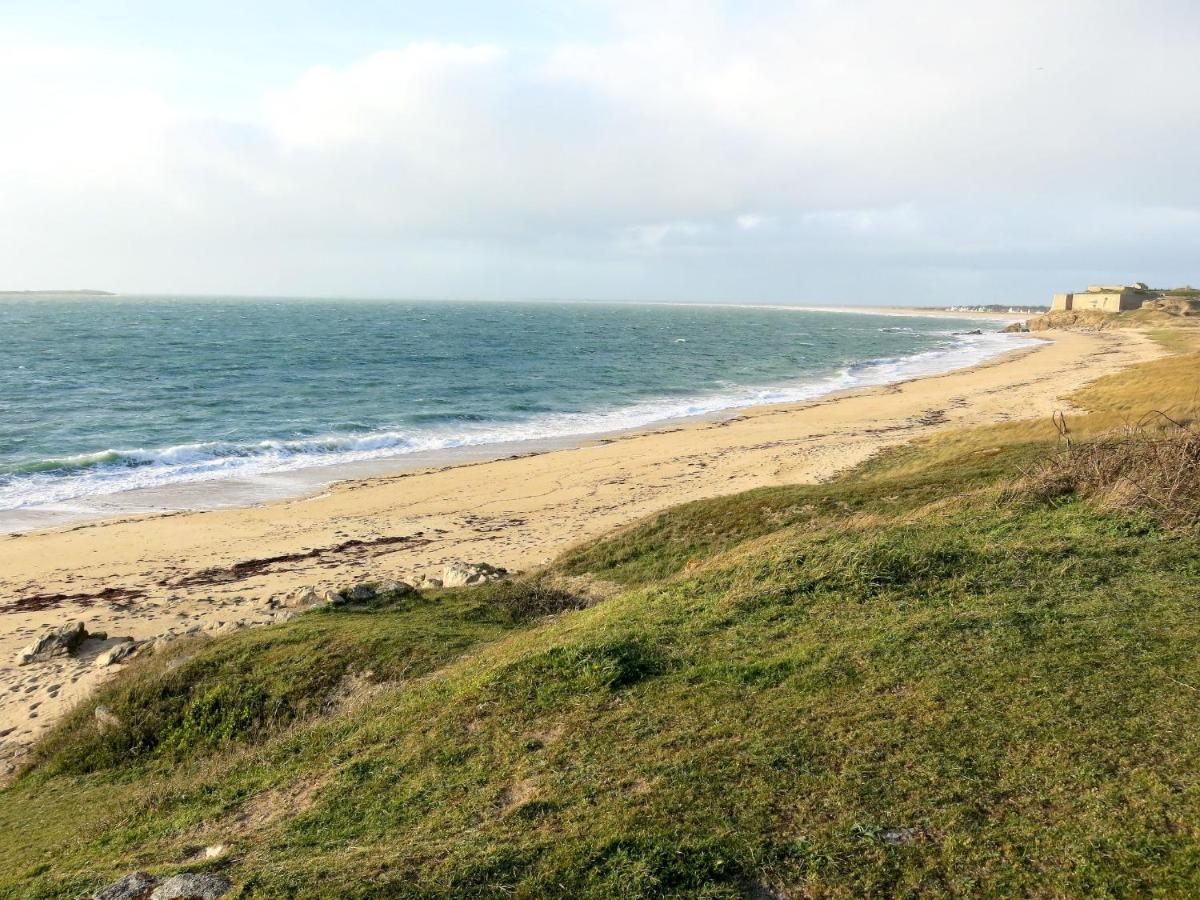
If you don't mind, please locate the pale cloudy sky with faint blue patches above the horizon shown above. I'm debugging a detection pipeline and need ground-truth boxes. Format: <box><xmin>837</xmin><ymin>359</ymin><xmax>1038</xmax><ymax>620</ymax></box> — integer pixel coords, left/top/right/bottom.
<box><xmin>0</xmin><ymin>0</ymin><xmax>1200</xmax><ymax>305</ymax></box>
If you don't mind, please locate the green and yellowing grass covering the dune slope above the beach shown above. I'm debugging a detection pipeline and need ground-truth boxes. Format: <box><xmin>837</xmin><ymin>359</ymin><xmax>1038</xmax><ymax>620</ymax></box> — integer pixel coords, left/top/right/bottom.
<box><xmin>0</xmin><ymin>336</ymin><xmax>1200</xmax><ymax>898</ymax></box>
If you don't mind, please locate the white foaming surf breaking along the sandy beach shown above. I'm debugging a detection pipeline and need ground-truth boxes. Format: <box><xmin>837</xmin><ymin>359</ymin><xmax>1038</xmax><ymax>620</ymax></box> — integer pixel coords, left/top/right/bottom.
<box><xmin>0</xmin><ymin>334</ymin><xmax>1032</xmax><ymax>510</ymax></box>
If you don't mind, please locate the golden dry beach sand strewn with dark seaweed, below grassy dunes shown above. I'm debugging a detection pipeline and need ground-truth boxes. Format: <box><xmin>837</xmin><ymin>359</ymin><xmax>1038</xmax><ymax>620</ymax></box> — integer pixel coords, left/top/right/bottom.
<box><xmin>0</xmin><ymin>331</ymin><xmax>1160</xmax><ymax>774</ymax></box>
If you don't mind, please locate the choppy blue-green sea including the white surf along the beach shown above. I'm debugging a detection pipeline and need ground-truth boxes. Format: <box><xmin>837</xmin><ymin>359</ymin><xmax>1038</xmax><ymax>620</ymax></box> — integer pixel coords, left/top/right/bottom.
<box><xmin>0</xmin><ymin>296</ymin><xmax>1027</xmax><ymax>512</ymax></box>
